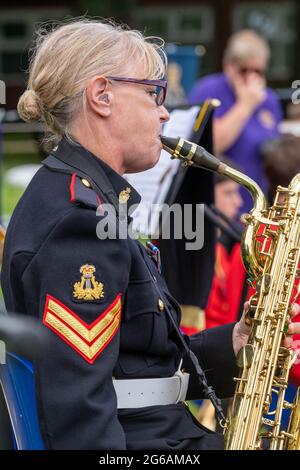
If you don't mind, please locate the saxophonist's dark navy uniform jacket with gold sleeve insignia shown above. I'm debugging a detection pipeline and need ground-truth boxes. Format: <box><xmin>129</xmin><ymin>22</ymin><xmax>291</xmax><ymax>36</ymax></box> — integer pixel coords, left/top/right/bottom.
<box><xmin>2</xmin><ymin>139</ymin><xmax>236</xmax><ymax>449</ymax></box>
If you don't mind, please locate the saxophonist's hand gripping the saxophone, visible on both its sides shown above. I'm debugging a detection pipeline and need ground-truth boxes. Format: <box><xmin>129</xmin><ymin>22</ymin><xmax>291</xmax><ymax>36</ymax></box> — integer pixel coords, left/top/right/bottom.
<box><xmin>232</xmin><ymin>302</ymin><xmax>300</xmax><ymax>356</ymax></box>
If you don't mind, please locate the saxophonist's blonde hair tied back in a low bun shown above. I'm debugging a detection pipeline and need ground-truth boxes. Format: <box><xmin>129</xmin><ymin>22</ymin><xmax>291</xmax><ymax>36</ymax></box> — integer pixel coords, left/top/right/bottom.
<box><xmin>18</xmin><ymin>18</ymin><xmax>166</xmax><ymax>145</ymax></box>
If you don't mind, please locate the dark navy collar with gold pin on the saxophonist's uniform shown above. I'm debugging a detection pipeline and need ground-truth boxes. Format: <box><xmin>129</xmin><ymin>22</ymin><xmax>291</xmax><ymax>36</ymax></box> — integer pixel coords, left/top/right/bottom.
<box><xmin>52</xmin><ymin>137</ymin><xmax>141</xmax><ymax>208</ymax></box>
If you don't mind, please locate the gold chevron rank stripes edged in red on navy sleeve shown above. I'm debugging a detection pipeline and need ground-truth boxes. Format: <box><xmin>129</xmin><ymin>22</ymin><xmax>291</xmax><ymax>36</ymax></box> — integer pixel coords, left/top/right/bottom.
<box><xmin>43</xmin><ymin>294</ymin><xmax>121</xmax><ymax>364</ymax></box>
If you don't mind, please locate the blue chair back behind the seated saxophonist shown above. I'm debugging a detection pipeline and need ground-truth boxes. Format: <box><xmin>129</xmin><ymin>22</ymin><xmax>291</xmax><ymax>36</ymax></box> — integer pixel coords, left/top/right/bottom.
<box><xmin>0</xmin><ymin>353</ymin><xmax>45</xmax><ymax>450</ymax></box>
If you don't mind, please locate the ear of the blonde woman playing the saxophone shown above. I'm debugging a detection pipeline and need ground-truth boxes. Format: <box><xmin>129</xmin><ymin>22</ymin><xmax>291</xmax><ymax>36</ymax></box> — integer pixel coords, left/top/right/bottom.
<box><xmin>86</xmin><ymin>76</ymin><xmax>113</xmax><ymax>117</ymax></box>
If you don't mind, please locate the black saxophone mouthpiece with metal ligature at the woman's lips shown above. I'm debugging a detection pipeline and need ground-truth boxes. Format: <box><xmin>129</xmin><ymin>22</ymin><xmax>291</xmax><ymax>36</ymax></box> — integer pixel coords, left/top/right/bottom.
<box><xmin>160</xmin><ymin>135</ymin><xmax>225</xmax><ymax>173</ymax></box>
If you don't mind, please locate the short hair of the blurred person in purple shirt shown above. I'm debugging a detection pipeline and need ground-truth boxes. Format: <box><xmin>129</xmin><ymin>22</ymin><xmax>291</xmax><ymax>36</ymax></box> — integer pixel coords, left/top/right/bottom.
<box><xmin>223</xmin><ymin>29</ymin><xmax>270</xmax><ymax>63</ymax></box>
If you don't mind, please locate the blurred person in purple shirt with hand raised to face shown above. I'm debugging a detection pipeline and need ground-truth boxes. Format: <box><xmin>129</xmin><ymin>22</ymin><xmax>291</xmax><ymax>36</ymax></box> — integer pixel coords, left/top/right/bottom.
<box><xmin>189</xmin><ymin>30</ymin><xmax>282</xmax><ymax>212</ymax></box>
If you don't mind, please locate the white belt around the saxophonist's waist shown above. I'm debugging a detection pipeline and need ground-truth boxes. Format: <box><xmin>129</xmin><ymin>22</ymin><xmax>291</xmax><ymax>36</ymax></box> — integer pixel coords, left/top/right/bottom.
<box><xmin>113</xmin><ymin>370</ymin><xmax>190</xmax><ymax>409</ymax></box>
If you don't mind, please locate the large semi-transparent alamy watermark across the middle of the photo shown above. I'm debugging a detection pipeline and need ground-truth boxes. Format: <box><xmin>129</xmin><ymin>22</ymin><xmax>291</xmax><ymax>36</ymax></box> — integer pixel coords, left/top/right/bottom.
<box><xmin>96</xmin><ymin>204</ymin><xmax>204</xmax><ymax>250</ymax></box>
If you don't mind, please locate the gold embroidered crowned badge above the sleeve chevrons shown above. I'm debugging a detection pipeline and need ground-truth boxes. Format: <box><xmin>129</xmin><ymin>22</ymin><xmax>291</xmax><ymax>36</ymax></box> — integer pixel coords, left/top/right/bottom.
<box><xmin>73</xmin><ymin>264</ymin><xmax>104</xmax><ymax>301</ymax></box>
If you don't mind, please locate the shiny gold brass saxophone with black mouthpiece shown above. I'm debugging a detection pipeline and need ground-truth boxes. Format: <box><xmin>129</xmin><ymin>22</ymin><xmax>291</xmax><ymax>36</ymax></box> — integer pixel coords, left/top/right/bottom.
<box><xmin>161</xmin><ymin>136</ymin><xmax>300</xmax><ymax>450</ymax></box>
